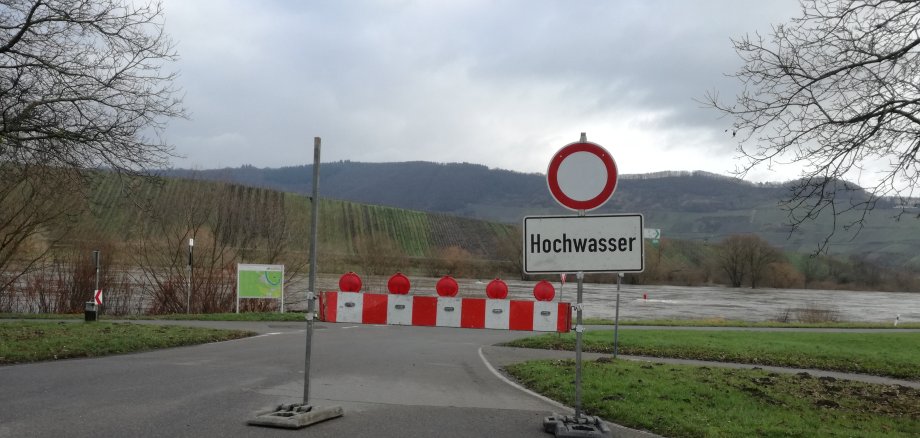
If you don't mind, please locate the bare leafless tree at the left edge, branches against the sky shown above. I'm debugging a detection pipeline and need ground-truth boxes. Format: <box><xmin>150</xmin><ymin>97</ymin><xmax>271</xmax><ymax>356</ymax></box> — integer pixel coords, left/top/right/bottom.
<box><xmin>0</xmin><ymin>0</ymin><xmax>184</xmax><ymax>300</ymax></box>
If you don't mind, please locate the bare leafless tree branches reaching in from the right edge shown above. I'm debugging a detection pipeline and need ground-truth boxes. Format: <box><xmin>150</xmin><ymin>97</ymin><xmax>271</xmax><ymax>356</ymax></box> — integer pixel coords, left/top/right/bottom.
<box><xmin>706</xmin><ymin>0</ymin><xmax>920</xmax><ymax>251</ymax></box>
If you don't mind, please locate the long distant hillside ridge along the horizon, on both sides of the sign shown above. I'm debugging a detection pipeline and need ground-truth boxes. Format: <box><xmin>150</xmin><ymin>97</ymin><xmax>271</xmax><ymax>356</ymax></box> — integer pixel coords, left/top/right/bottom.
<box><xmin>162</xmin><ymin>161</ymin><xmax>920</xmax><ymax>268</ymax></box>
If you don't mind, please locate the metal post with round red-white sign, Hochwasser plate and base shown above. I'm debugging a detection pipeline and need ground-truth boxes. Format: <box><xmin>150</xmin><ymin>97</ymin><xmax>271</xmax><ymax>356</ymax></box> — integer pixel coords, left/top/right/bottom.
<box><xmin>536</xmin><ymin>133</ymin><xmax>620</xmax><ymax>438</ymax></box>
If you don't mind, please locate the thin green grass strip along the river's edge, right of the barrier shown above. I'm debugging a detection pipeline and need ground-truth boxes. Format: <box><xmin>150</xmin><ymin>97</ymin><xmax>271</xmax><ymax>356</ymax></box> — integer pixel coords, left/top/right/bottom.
<box><xmin>584</xmin><ymin>318</ymin><xmax>920</xmax><ymax>329</ymax></box>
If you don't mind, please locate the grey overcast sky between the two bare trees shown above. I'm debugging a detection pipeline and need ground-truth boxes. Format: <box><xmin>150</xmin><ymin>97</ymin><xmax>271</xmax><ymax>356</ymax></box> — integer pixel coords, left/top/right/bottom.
<box><xmin>165</xmin><ymin>0</ymin><xmax>798</xmax><ymax>181</ymax></box>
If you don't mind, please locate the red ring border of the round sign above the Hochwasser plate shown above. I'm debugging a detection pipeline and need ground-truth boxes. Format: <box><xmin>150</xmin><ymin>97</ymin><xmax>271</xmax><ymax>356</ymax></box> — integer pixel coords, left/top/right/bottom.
<box><xmin>546</xmin><ymin>141</ymin><xmax>618</xmax><ymax>211</ymax></box>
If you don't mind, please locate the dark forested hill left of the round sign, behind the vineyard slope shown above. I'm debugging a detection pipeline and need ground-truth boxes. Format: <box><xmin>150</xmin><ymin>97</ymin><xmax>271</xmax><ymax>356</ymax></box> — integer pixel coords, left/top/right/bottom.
<box><xmin>165</xmin><ymin>161</ymin><xmax>552</xmax><ymax>222</ymax></box>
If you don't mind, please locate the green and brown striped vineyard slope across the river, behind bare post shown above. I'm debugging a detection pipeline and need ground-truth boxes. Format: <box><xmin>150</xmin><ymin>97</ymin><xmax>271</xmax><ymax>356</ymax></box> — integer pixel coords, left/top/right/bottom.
<box><xmin>72</xmin><ymin>175</ymin><xmax>517</xmax><ymax>260</ymax></box>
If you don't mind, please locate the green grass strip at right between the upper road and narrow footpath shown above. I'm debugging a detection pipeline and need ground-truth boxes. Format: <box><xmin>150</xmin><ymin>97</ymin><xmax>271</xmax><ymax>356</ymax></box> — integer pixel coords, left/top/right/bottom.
<box><xmin>506</xmin><ymin>330</ymin><xmax>920</xmax><ymax>380</ymax></box>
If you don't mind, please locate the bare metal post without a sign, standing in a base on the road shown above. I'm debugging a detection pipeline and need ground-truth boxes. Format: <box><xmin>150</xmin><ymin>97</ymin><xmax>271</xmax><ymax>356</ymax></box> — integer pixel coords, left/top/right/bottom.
<box><xmin>247</xmin><ymin>137</ymin><xmax>345</xmax><ymax>429</ymax></box>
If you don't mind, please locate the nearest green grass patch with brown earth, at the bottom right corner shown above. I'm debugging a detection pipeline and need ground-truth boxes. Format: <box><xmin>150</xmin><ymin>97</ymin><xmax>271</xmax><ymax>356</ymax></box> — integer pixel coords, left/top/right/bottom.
<box><xmin>506</xmin><ymin>360</ymin><xmax>920</xmax><ymax>438</ymax></box>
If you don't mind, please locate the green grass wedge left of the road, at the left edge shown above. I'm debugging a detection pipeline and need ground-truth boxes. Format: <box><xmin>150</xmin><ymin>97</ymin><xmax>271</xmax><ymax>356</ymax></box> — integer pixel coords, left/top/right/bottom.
<box><xmin>0</xmin><ymin>321</ymin><xmax>255</xmax><ymax>364</ymax></box>
